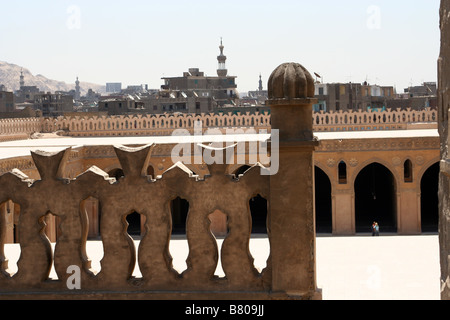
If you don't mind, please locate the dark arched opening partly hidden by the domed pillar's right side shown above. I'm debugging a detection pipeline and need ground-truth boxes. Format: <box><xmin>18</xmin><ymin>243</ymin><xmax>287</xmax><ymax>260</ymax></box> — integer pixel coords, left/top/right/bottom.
<box><xmin>314</xmin><ymin>167</ymin><xmax>333</xmax><ymax>233</ymax></box>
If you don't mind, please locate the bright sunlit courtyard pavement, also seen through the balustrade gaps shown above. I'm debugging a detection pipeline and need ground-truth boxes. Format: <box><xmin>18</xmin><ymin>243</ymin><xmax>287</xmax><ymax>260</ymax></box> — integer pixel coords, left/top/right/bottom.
<box><xmin>1</xmin><ymin>235</ymin><xmax>440</xmax><ymax>300</ymax></box>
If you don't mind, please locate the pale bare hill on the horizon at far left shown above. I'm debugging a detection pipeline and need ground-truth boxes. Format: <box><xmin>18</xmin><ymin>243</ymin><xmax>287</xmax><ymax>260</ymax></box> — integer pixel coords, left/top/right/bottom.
<box><xmin>0</xmin><ymin>61</ymin><xmax>106</xmax><ymax>96</ymax></box>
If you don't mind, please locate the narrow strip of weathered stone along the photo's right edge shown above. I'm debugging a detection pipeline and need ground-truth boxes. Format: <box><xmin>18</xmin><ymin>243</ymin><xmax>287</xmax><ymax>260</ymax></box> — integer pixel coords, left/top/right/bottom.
<box><xmin>438</xmin><ymin>0</ymin><xmax>450</xmax><ymax>300</ymax></box>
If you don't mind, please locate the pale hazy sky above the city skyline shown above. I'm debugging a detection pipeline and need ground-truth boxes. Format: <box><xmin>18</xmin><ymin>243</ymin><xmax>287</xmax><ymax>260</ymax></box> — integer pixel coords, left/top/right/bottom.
<box><xmin>0</xmin><ymin>0</ymin><xmax>440</xmax><ymax>92</ymax></box>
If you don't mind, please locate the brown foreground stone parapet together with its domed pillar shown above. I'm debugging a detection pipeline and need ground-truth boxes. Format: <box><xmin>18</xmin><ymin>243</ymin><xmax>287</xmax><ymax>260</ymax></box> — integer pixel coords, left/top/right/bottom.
<box><xmin>0</xmin><ymin>64</ymin><xmax>322</xmax><ymax>299</ymax></box>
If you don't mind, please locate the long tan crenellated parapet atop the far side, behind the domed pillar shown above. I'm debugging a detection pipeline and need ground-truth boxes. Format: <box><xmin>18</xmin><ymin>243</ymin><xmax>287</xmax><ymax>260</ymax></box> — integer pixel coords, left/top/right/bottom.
<box><xmin>33</xmin><ymin>109</ymin><xmax>438</xmax><ymax>137</ymax></box>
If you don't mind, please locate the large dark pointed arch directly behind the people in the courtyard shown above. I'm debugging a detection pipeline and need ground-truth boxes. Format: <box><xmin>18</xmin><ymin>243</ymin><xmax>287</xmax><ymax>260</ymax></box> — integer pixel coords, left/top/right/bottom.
<box><xmin>355</xmin><ymin>163</ymin><xmax>397</xmax><ymax>232</ymax></box>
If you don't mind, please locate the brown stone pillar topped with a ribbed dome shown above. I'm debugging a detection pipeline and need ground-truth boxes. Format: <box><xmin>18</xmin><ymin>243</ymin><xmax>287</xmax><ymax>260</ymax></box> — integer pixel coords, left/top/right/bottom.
<box><xmin>268</xmin><ymin>63</ymin><xmax>322</xmax><ymax>299</ymax></box>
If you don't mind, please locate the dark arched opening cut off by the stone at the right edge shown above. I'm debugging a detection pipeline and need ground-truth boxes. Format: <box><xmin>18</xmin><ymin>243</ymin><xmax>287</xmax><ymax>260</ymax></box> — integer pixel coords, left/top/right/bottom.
<box><xmin>420</xmin><ymin>163</ymin><xmax>440</xmax><ymax>232</ymax></box>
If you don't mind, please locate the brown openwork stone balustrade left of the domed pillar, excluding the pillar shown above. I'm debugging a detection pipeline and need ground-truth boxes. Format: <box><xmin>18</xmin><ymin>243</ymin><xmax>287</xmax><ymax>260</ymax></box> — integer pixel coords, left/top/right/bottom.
<box><xmin>0</xmin><ymin>145</ymin><xmax>274</xmax><ymax>299</ymax></box>
